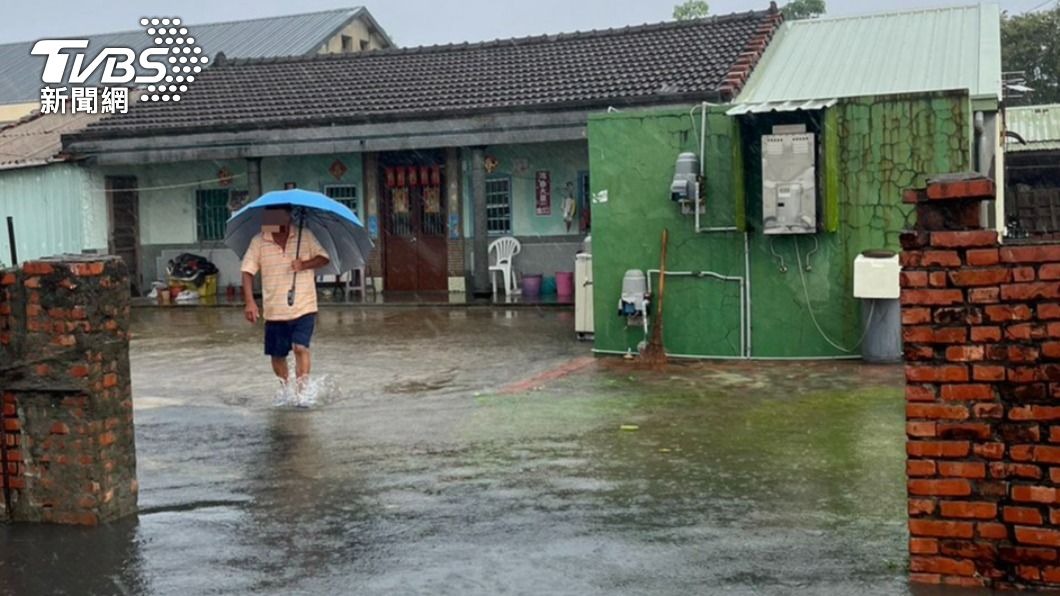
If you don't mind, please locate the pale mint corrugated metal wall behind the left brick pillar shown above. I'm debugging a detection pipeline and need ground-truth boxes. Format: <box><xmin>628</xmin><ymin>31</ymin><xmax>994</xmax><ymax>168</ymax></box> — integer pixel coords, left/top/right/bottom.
<box><xmin>0</xmin><ymin>163</ymin><xmax>107</xmax><ymax>263</ymax></box>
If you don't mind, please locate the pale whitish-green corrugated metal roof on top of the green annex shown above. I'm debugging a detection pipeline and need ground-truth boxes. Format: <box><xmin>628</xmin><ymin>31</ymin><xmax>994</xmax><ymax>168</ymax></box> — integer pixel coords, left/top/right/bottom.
<box><xmin>735</xmin><ymin>4</ymin><xmax>1001</xmax><ymax>104</ymax></box>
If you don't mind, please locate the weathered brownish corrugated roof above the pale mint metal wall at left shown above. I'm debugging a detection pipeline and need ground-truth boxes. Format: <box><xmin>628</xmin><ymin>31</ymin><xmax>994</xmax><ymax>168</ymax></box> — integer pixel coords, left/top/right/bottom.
<box><xmin>0</xmin><ymin>109</ymin><xmax>103</xmax><ymax>170</ymax></box>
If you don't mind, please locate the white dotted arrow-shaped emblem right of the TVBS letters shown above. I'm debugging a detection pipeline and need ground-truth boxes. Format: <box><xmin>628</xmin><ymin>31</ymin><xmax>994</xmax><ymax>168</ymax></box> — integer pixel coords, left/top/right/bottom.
<box><xmin>134</xmin><ymin>17</ymin><xmax>204</xmax><ymax>102</ymax></box>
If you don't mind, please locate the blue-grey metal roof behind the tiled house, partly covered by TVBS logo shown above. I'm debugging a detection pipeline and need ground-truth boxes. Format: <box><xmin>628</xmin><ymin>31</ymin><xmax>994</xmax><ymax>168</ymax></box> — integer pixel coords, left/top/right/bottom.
<box><xmin>0</xmin><ymin>6</ymin><xmax>377</xmax><ymax>104</ymax></box>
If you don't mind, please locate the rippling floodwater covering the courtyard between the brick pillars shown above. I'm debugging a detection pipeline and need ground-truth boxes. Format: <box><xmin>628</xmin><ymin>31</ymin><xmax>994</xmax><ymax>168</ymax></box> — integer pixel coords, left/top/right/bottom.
<box><xmin>0</xmin><ymin>308</ymin><xmax>983</xmax><ymax>595</ymax></box>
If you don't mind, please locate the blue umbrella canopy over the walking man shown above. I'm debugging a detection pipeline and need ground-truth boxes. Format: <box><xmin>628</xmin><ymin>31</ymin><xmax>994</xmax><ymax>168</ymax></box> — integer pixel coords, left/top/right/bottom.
<box><xmin>225</xmin><ymin>189</ymin><xmax>373</xmax><ymax>275</ymax></box>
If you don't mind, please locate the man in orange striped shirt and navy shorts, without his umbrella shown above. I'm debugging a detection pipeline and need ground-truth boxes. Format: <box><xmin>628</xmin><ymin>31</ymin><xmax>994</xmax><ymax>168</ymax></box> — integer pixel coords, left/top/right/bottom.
<box><xmin>241</xmin><ymin>206</ymin><xmax>330</xmax><ymax>395</ymax></box>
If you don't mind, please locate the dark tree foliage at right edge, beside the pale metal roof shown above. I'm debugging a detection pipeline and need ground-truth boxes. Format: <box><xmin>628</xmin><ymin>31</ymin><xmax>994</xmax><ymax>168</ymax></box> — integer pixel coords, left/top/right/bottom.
<box><xmin>1001</xmin><ymin>4</ymin><xmax>1060</xmax><ymax>104</ymax></box>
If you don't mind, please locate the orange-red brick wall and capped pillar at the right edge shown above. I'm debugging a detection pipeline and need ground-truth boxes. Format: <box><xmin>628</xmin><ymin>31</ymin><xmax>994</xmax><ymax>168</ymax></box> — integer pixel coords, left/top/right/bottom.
<box><xmin>901</xmin><ymin>170</ymin><xmax>1060</xmax><ymax>589</ymax></box>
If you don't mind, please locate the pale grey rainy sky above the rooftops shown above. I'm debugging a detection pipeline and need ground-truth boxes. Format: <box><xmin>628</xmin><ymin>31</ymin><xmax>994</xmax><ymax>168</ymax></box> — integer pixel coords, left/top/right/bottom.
<box><xmin>0</xmin><ymin>0</ymin><xmax>1058</xmax><ymax>47</ymax></box>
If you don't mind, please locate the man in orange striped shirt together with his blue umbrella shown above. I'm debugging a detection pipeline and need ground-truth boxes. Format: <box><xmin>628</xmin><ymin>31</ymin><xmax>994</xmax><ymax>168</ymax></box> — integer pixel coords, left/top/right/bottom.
<box><xmin>225</xmin><ymin>189</ymin><xmax>372</xmax><ymax>405</ymax></box>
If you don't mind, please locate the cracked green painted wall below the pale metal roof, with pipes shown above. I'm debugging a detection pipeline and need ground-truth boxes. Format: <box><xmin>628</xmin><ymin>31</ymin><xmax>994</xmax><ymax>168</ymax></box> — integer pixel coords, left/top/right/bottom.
<box><xmin>589</xmin><ymin>94</ymin><xmax>971</xmax><ymax>357</ymax></box>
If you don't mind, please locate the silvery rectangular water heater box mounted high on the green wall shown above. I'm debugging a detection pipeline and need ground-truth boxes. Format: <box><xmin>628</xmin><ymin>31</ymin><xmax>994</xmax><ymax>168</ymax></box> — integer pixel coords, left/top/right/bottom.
<box><xmin>762</xmin><ymin>133</ymin><xmax>817</xmax><ymax>234</ymax></box>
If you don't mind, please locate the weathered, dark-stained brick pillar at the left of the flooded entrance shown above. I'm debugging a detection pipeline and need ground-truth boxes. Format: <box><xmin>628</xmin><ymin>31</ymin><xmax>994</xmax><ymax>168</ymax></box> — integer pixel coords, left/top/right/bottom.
<box><xmin>0</xmin><ymin>256</ymin><xmax>138</xmax><ymax>525</ymax></box>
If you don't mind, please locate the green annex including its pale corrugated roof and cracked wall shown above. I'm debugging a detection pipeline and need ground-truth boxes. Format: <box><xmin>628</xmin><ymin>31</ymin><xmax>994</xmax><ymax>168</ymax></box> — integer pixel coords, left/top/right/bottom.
<box><xmin>589</xmin><ymin>4</ymin><xmax>1004</xmax><ymax>358</ymax></box>
